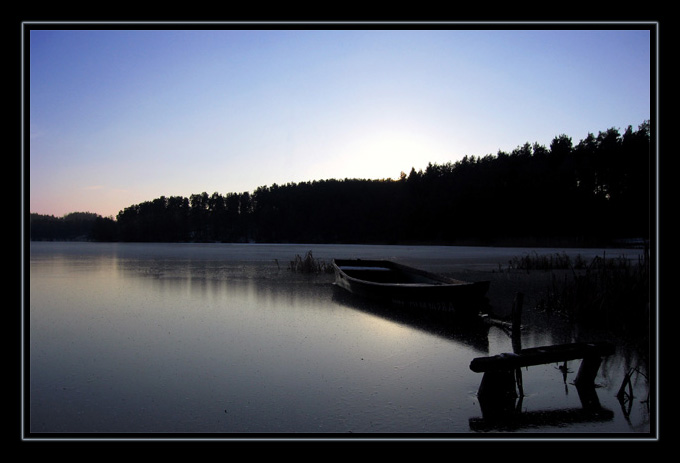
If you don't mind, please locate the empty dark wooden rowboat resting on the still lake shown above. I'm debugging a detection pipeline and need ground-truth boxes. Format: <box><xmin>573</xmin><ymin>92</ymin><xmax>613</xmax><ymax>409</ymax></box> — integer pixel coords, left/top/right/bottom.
<box><xmin>333</xmin><ymin>259</ymin><xmax>490</xmax><ymax>312</ymax></box>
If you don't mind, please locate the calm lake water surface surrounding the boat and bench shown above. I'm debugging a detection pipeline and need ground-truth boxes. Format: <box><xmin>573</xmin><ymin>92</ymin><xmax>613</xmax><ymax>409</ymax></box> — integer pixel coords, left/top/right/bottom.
<box><xmin>24</xmin><ymin>242</ymin><xmax>655</xmax><ymax>439</ymax></box>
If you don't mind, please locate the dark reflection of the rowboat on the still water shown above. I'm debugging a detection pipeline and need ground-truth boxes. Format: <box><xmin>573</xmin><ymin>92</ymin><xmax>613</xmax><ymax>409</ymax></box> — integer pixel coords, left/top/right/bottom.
<box><xmin>332</xmin><ymin>285</ymin><xmax>489</xmax><ymax>353</ymax></box>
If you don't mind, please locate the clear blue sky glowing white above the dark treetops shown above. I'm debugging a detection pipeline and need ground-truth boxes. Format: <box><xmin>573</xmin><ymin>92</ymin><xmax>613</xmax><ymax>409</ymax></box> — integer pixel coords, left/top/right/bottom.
<box><xmin>23</xmin><ymin>24</ymin><xmax>655</xmax><ymax>217</ymax></box>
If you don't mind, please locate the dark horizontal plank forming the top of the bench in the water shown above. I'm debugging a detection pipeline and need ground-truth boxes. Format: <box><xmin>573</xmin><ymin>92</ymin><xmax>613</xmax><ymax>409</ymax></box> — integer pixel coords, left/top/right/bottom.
<box><xmin>470</xmin><ymin>343</ymin><xmax>614</xmax><ymax>373</ymax></box>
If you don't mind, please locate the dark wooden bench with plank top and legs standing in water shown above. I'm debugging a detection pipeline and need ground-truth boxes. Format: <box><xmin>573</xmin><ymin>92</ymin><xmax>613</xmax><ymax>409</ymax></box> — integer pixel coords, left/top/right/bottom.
<box><xmin>470</xmin><ymin>343</ymin><xmax>615</xmax><ymax>395</ymax></box>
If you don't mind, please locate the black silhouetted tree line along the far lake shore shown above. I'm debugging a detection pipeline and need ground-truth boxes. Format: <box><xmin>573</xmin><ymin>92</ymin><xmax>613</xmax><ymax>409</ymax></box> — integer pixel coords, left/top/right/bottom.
<box><xmin>31</xmin><ymin>121</ymin><xmax>652</xmax><ymax>245</ymax></box>
